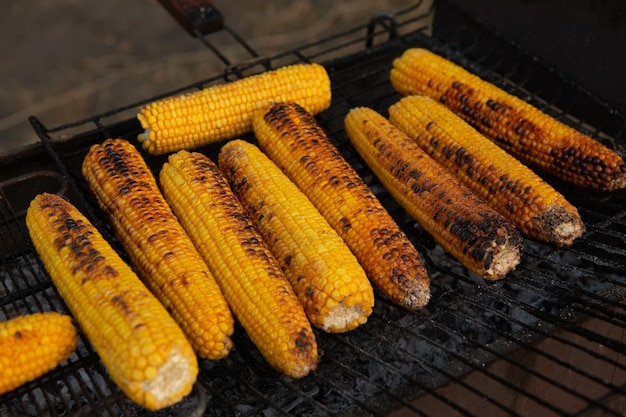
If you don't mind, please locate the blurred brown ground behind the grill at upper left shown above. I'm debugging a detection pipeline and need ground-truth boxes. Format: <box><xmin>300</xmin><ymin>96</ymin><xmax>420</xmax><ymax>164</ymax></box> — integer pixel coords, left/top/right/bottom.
<box><xmin>0</xmin><ymin>0</ymin><xmax>426</xmax><ymax>153</ymax></box>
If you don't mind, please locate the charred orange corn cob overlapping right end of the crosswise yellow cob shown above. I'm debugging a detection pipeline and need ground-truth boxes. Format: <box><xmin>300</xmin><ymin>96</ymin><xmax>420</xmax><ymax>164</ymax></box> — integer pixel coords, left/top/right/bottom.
<box><xmin>253</xmin><ymin>103</ymin><xmax>430</xmax><ymax>309</ymax></box>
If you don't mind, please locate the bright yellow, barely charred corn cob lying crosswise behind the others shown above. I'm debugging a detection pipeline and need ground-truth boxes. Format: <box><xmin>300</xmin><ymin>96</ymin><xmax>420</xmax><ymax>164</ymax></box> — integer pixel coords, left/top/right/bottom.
<box><xmin>137</xmin><ymin>64</ymin><xmax>331</xmax><ymax>154</ymax></box>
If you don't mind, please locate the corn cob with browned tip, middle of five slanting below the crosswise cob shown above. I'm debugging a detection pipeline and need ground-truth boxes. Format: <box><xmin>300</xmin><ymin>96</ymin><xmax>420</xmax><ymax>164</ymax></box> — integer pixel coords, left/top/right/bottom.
<box><xmin>159</xmin><ymin>150</ymin><xmax>318</xmax><ymax>378</ymax></box>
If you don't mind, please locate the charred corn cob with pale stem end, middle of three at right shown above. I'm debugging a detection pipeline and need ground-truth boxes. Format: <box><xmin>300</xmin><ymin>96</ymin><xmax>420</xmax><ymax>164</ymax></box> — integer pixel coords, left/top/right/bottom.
<box><xmin>389</xmin><ymin>96</ymin><xmax>584</xmax><ymax>246</ymax></box>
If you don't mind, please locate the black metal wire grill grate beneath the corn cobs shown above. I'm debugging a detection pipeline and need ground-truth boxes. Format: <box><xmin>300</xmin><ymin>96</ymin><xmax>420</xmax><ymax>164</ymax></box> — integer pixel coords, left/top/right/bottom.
<box><xmin>0</xmin><ymin>1</ymin><xmax>626</xmax><ymax>417</ymax></box>
